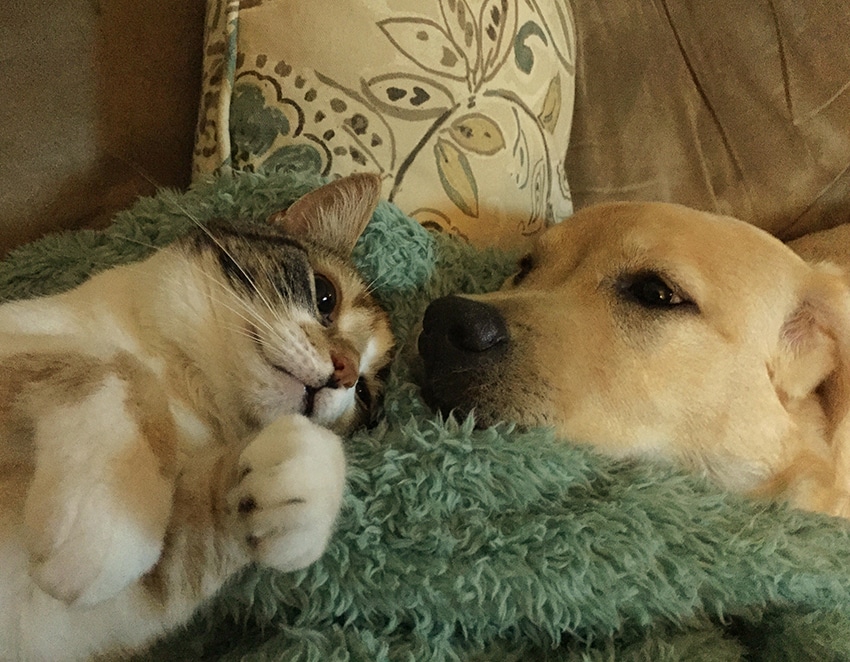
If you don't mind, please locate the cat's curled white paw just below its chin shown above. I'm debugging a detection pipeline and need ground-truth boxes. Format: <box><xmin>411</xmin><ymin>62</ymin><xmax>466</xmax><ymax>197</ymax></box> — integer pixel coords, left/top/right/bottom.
<box><xmin>228</xmin><ymin>415</ymin><xmax>345</xmax><ymax>571</ymax></box>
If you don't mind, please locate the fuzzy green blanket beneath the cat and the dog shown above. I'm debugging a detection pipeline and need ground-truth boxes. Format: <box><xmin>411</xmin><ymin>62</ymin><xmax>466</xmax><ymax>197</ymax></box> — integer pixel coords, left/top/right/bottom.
<box><xmin>0</xmin><ymin>173</ymin><xmax>850</xmax><ymax>662</ymax></box>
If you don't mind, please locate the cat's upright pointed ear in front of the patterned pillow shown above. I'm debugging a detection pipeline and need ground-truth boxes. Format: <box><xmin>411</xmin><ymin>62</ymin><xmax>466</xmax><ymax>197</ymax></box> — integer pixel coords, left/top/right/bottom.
<box><xmin>268</xmin><ymin>173</ymin><xmax>381</xmax><ymax>256</ymax></box>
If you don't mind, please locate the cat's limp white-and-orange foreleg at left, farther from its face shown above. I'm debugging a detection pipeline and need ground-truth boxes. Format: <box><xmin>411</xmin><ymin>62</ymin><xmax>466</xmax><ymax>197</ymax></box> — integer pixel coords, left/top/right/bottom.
<box><xmin>24</xmin><ymin>376</ymin><xmax>173</xmax><ymax>606</ymax></box>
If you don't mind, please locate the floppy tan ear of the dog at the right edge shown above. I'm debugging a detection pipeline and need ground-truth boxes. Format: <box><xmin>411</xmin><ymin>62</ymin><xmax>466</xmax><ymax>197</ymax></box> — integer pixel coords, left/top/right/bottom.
<box><xmin>770</xmin><ymin>265</ymin><xmax>850</xmax><ymax>508</ymax></box>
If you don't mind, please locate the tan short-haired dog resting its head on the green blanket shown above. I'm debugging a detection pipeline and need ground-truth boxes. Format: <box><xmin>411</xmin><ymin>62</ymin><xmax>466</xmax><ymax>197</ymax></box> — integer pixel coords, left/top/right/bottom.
<box><xmin>418</xmin><ymin>203</ymin><xmax>850</xmax><ymax>517</ymax></box>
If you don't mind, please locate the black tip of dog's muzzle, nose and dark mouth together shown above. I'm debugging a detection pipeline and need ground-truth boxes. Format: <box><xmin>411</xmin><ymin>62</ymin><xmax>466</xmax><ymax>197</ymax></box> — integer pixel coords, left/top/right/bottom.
<box><xmin>419</xmin><ymin>296</ymin><xmax>510</xmax><ymax>413</ymax></box>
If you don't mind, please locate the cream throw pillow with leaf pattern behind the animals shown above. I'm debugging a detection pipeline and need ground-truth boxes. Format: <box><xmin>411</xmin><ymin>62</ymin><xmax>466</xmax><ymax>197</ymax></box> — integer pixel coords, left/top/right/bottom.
<box><xmin>195</xmin><ymin>0</ymin><xmax>575</xmax><ymax>248</ymax></box>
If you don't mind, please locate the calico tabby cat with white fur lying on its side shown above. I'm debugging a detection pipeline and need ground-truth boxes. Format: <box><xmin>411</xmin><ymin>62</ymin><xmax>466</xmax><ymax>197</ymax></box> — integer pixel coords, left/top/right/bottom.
<box><xmin>0</xmin><ymin>175</ymin><xmax>393</xmax><ymax>661</ymax></box>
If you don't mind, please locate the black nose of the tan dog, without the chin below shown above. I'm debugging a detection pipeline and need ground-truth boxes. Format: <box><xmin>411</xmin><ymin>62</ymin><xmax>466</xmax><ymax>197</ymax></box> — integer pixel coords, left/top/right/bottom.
<box><xmin>419</xmin><ymin>296</ymin><xmax>509</xmax><ymax>368</ymax></box>
